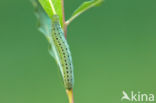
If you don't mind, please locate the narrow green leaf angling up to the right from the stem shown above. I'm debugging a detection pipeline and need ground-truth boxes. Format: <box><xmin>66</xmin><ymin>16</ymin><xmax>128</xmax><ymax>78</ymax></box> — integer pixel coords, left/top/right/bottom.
<box><xmin>66</xmin><ymin>0</ymin><xmax>103</xmax><ymax>24</ymax></box>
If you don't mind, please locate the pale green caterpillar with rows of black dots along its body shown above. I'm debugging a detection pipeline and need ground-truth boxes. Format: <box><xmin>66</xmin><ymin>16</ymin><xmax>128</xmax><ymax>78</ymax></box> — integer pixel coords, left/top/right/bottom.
<box><xmin>51</xmin><ymin>15</ymin><xmax>74</xmax><ymax>90</ymax></box>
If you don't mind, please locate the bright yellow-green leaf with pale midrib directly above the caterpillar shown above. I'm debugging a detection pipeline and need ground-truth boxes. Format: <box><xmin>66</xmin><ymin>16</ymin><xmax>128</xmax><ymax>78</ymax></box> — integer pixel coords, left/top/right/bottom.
<box><xmin>39</xmin><ymin>0</ymin><xmax>64</xmax><ymax>28</ymax></box>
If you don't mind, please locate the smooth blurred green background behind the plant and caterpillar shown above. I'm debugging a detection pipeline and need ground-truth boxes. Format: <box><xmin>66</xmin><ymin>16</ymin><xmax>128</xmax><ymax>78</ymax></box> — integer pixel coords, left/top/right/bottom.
<box><xmin>0</xmin><ymin>0</ymin><xmax>156</xmax><ymax>103</ymax></box>
